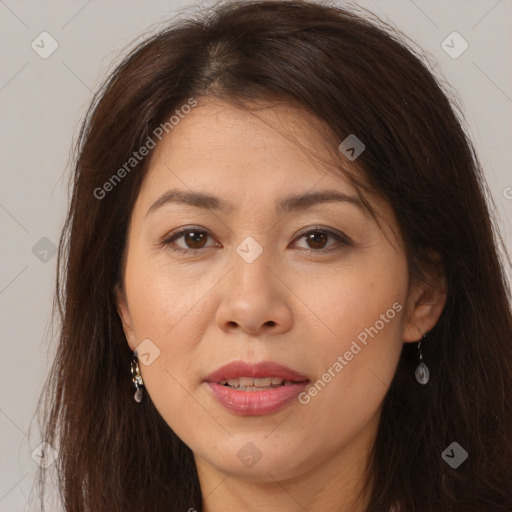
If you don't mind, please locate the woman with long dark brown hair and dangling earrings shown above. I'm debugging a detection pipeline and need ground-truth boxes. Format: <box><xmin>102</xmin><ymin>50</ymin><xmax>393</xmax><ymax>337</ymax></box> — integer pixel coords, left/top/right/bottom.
<box><xmin>37</xmin><ymin>1</ymin><xmax>512</xmax><ymax>512</ymax></box>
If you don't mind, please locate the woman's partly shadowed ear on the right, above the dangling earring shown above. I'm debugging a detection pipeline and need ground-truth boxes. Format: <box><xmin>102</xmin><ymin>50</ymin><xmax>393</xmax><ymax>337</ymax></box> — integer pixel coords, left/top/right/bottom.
<box><xmin>403</xmin><ymin>254</ymin><xmax>447</xmax><ymax>343</ymax></box>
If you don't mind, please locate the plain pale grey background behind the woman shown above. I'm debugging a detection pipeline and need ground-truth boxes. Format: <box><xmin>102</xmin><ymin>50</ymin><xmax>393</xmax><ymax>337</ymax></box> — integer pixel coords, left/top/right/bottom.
<box><xmin>0</xmin><ymin>0</ymin><xmax>512</xmax><ymax>512</ymax></box>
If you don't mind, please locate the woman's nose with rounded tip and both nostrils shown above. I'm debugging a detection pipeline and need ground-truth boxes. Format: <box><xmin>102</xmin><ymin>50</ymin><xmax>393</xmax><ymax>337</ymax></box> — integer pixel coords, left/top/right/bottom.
<box><xmin>212</xmin><ymin>247</ymin><xmax>293</xmax><ymax>336</ymax></box>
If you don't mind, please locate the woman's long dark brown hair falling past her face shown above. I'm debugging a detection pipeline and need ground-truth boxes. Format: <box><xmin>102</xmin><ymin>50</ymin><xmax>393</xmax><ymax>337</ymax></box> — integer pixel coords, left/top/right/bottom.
<box><xmin>34</xmin><ymin>0</ymin><xmax>512</xmax><ymax>512</ymax></box>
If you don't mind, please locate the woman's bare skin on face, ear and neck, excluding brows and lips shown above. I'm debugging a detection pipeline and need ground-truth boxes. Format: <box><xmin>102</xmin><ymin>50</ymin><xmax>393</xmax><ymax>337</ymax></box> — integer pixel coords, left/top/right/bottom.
<box><xmin>118</xmin><ymin>100</ymin><xmax>446</xmax><ymax>512</ymax></box>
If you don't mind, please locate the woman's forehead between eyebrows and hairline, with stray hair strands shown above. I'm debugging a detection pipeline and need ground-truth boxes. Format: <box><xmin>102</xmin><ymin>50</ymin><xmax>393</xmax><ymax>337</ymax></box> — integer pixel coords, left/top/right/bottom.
<box><xmin>136</xmin><ymin>100</ymin><xmax>358</xmax><ymax>204</ymax></box>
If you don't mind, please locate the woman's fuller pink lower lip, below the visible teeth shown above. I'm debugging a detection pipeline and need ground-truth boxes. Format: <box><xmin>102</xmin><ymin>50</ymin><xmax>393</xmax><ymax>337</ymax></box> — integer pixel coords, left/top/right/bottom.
<box><xmin>206</xmin><ymin>381</ymin><xmax>309</xmax><ymax>416</ymax></box>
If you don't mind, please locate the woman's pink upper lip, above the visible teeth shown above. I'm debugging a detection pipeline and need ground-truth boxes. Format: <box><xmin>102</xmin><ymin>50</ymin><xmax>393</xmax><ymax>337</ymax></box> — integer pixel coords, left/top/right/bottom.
<box><xmin>205</xmin><ymin>361</ymin><xmax>309</xmax><ymax>383</ymax></box>
